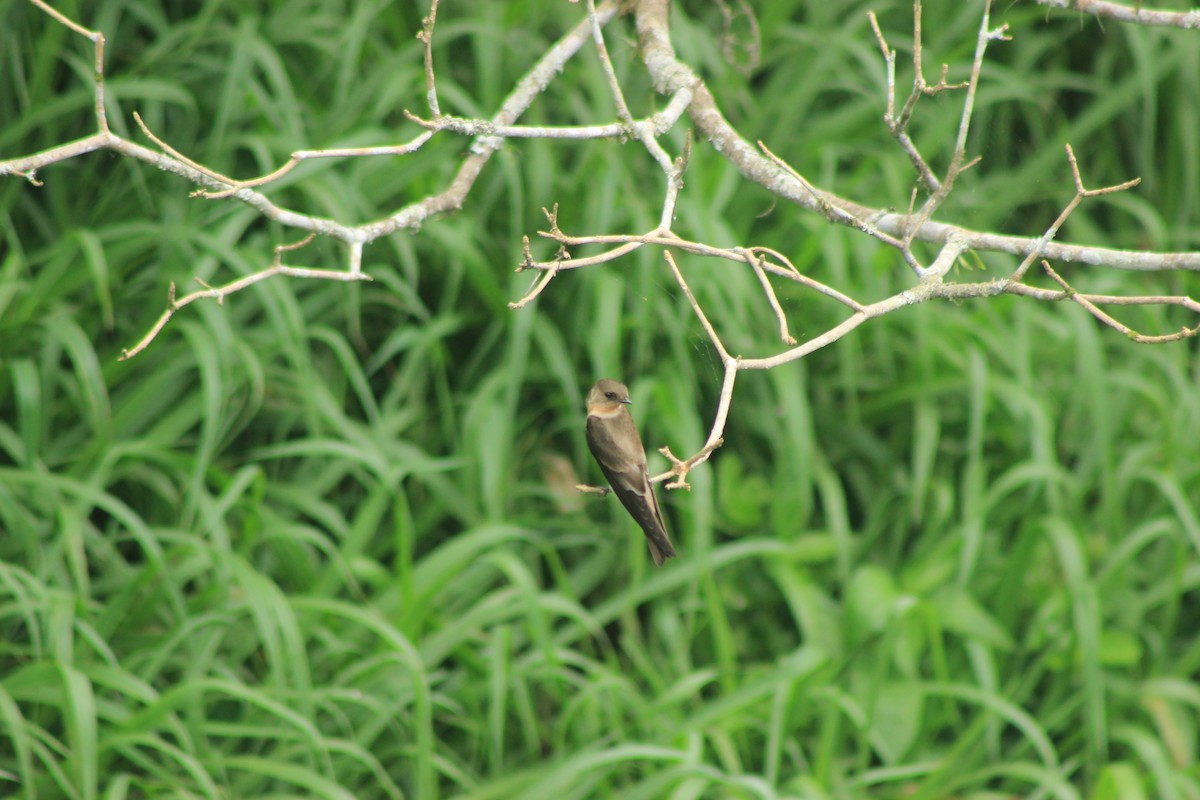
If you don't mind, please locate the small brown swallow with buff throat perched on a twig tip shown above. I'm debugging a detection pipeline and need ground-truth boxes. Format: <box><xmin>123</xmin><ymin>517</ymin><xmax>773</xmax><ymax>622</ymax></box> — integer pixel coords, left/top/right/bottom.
<box><xmin>588</xmin><ymin>378</ymin><xmax>674</xmax><ymax>566</ymax></box>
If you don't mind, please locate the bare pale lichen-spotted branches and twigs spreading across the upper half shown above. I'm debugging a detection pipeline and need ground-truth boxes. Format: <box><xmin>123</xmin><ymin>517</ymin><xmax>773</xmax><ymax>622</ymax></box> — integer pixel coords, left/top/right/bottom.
<box><xmin>0</xmin><ymin>0</ymin><xmax>1200</xmax><ymax>494</ymax></box>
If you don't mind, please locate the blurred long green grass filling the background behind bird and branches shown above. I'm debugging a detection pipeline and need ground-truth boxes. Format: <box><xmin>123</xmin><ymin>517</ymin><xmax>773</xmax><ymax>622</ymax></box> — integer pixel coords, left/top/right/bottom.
<box><xmin>0</xmin><ymin>0</ymin><xmax>1200</xmax><ymax>800</ymax></box>
